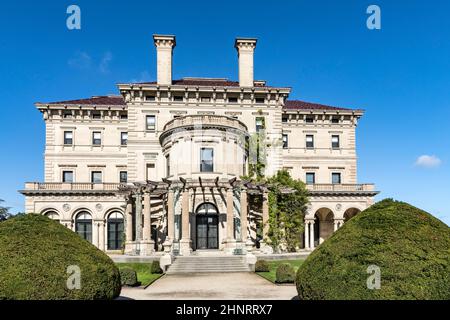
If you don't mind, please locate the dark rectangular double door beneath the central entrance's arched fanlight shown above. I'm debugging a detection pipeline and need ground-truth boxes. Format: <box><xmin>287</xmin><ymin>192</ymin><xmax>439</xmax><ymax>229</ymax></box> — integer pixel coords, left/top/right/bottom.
<box><xmin>197</xmin><ymin>215</ymin><xmax>219</xmax><ymax>249</ymax></box>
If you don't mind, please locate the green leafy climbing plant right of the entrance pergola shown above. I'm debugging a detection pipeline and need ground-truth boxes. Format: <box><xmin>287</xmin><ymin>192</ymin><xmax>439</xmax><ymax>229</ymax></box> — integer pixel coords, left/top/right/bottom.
<box><xmin>266</xmin><ymin>170</ymin><xmax>309</xmax><ymax>252</ymax></box>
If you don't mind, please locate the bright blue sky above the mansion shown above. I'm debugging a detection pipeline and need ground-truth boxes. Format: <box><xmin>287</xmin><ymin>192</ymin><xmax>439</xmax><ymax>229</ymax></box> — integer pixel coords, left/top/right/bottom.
<box><xmin>0</xmin><ymin>0</ymin><xmax>450</xmax><ymax>224</ymax></box>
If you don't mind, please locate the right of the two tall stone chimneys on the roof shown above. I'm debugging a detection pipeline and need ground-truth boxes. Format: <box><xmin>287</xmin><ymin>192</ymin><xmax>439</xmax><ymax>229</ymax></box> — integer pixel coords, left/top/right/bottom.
<box><xmin>234</xmin><ymin>38</ymin><xmax>256</xmax><ymax>87</ymax></box>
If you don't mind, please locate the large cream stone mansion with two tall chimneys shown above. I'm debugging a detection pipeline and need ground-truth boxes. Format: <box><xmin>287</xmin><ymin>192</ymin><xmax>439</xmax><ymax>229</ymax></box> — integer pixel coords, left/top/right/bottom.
<box><xmin>20</xmin><ymin>35</ymin><xmax>377</xmax><ymax>256</ymax></box>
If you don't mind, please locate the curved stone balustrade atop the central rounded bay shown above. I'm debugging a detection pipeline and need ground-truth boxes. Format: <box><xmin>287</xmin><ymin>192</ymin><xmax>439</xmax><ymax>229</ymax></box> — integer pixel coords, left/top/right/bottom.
<box><xmin>164</xmin><ymin>114</ymin><xmax>247</xmax><ymax>131</ymax></box>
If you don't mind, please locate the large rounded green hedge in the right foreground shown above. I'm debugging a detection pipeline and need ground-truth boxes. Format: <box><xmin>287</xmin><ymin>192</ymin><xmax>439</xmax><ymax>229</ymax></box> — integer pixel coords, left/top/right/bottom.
<box><xmin>297</xmin><ymin>199</ymin><xmax>450</xmax><ymax>300</ymax></box>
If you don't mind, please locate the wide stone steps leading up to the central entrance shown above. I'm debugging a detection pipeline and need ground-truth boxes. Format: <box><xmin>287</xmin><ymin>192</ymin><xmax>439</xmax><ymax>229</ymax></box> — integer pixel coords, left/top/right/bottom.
<box><xmin>167</xmin><ymin>255</ymin><xmax>250</xmax><ymax>274</ymax></box>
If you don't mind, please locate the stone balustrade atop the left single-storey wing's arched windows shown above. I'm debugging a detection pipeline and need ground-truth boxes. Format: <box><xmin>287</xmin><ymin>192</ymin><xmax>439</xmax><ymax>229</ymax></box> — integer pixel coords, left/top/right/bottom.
<box><xmin>25</xmin><ymin>182</ymin><xmax>120</xmax><ymax>191</ymax></box>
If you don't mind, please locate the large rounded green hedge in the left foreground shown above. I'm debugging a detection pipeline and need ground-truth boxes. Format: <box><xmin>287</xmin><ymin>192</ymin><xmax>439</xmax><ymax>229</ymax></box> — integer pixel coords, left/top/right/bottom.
<box><xmin>0</xmin><ymin>214</ymin><xmax>121</xmax><ymax>300</ymax></box>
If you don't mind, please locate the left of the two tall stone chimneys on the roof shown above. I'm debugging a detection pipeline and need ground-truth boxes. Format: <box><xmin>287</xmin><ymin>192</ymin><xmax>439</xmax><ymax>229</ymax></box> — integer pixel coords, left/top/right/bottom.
<box><xmin>153</xmin><ymin>34</ymin><xmax>176</xmax><ymax>85</ymax></box>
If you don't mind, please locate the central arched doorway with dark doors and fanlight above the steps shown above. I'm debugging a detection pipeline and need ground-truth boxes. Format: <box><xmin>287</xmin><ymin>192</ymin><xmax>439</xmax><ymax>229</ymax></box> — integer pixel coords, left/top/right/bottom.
<box><xmin>195</xmin><ymin>202</ymin><xmax>219</xmax><ymax>249</ymax></box>
